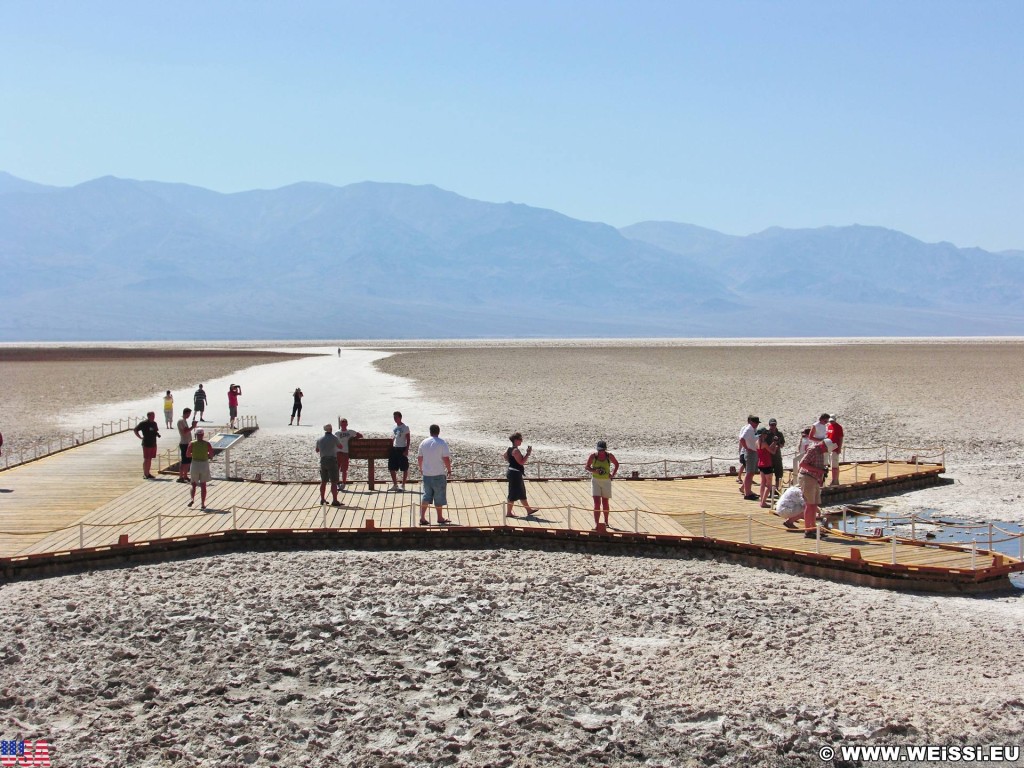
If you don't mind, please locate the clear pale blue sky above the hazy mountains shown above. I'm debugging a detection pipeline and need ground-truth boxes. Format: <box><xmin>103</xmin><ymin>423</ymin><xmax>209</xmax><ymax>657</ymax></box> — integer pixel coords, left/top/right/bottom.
<box><xmin>0</xmin><ymin>0</ymin><xmax>1024</xmax><ymax>250</ymax></box>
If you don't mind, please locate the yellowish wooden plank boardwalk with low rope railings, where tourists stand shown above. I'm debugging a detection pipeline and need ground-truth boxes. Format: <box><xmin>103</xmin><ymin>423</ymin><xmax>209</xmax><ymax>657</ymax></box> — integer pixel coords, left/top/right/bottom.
<box><xmin>0</xmin><ymin>434</ymin><xmax>1024</xmax><ymax>583</ymax></box>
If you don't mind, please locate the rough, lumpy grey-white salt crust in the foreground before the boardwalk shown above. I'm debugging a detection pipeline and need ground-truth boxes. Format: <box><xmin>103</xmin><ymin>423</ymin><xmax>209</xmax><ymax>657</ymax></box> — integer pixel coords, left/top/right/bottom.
<box><xmin>0</xmin><ymin>550</ymin><xmax>1024</xmax><ymax>766</ymax></box>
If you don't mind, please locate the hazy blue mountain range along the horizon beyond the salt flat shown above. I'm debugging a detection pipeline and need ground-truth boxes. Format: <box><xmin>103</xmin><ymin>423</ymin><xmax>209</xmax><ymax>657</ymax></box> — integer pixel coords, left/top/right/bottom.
<box><xmin>0</xmin><ymin>172</ymin><xmax>1024</xmax><ymax>341</ymax></box>
